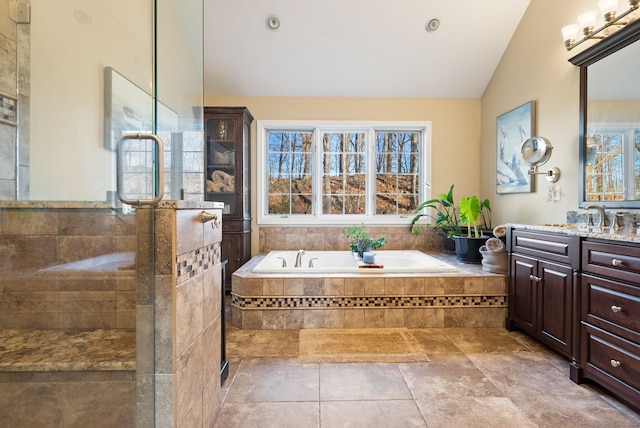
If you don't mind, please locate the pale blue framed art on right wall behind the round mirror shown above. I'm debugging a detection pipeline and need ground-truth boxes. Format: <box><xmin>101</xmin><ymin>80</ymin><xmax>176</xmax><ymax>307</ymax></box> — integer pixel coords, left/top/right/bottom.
<box><xmin>496</xmin><ymin>101</ymin><xmax>536</xmax><ymax>194</ymax></box>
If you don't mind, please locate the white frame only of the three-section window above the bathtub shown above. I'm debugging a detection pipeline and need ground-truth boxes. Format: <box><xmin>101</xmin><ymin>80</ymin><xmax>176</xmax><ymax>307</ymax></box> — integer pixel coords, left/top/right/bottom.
<box><xmin>256</xmin><ymin>120</ymin><xmax>431</xmax><ymax>226</ymax></box>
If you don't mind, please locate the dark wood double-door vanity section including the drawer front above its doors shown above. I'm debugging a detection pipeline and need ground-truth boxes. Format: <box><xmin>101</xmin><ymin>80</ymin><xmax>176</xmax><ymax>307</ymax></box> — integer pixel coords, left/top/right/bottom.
<box><xmin>507</xmin><ymin>229</ymin><xmax>580</xmax><ymax>359</ymax></box>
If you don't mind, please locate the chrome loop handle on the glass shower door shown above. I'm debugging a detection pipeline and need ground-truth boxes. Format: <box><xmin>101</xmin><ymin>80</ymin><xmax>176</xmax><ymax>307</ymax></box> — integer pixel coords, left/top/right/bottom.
<box><xmin>116</xmin><ymin>133</ymin><xmax>164</xmax><ymax>206</ymax></box>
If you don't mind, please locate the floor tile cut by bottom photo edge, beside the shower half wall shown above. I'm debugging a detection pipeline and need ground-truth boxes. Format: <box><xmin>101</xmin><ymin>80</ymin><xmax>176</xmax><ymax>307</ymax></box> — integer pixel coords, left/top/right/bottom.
<box><xmin>215</xmin><ymin>402</ymin><xmax>320</xmax><ymax>428</ymax></box>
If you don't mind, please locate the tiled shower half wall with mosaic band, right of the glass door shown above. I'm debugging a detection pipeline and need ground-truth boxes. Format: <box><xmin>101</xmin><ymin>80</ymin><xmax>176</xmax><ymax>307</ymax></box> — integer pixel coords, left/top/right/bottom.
<box><xmin>148</xmin><ymin>209</ymin><xmax>222</xmax><ymax>427</ymax></box>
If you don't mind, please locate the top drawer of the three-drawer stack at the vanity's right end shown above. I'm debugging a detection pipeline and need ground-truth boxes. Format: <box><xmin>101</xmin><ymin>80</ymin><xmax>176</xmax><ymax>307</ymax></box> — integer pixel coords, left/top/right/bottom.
<box><xmin>582</xmin><ymin>241</ymin><xmax>640</xmax><ymax>284</ymax></box>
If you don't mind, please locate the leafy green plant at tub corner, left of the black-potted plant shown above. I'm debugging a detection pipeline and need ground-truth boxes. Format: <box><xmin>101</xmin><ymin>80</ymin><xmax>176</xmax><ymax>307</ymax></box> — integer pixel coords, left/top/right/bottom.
<box><xmin>409</xmin><ymin>184</ymin><xmax>462</xmax><ymax>254</ymax></box>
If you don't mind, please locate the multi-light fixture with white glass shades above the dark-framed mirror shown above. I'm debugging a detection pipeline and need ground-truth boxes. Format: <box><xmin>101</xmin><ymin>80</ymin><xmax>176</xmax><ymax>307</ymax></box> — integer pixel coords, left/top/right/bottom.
<box><xmin>560</xmin><ymin>0</ymin><xmax>640</xmax><ymax>51</ymax></box>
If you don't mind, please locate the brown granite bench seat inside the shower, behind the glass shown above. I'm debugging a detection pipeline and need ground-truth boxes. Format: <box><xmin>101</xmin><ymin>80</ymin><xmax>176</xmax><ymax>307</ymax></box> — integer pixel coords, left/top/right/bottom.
<box><xmin>0</xmin><ymin>329</ymin><xmax>136</xmax><ymax>372</ymax></box>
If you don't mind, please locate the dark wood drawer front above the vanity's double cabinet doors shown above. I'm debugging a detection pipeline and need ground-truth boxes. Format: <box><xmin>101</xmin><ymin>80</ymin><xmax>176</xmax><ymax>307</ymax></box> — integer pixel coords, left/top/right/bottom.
<box><xmin>511</xmin><ymin>230</ymin><xmax>579</xmax><ymax>265</ymax></box>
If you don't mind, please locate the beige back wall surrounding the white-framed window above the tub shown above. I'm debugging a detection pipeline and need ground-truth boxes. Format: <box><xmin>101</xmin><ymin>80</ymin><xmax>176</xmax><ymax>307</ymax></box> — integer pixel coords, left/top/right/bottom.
<box><xmin>205</xmin><ymin>97</ymin><xmax>486</xmax><ymax>254</ymax></box>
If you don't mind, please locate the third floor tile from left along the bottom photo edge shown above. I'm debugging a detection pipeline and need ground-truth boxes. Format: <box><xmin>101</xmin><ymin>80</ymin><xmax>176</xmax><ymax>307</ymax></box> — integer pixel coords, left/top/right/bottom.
<box><xmin>417</xmin><ymin>397</ymin><xmax>537</xmax><ymax>428</ymax></box>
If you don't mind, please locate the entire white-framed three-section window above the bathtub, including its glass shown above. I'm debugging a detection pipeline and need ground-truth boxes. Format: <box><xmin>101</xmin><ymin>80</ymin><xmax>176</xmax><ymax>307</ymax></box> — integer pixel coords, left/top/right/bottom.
<box><xmin>257</xmin><ymin>121</ymin><xmax>431</xmax><ymax>224</ymax></box>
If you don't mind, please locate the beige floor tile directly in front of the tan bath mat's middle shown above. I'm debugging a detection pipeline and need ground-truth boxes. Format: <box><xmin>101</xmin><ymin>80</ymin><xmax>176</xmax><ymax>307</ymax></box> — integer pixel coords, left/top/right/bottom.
<box><xmin>320</xmin><ymin>363</ymin><xmax>411</xmax><ymax>401</ymax></box>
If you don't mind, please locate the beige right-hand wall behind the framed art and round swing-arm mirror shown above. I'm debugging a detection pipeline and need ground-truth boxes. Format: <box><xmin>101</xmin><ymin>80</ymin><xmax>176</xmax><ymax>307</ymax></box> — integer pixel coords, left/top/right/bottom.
<box><xmin>480</xmin><ymin>0</ymin><xmax>596</xmax><ymax>223</ymax></box>
